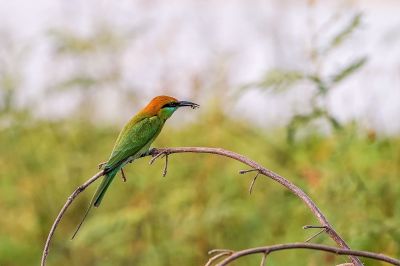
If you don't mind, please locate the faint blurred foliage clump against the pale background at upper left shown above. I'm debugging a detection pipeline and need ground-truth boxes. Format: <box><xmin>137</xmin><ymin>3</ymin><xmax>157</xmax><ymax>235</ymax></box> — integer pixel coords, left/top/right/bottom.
<box><xmin>44</xmin><ymin>25</ymin><xmax>137</xmax><ymax>120</ymax></box>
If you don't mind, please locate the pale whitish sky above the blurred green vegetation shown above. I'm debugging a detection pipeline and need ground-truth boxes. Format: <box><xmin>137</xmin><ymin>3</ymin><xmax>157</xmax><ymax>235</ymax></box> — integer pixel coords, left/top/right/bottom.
<box><xmin>0</xmin><ymin>0</ymin><xmax>400</xmax><ymax>134</ymax></box>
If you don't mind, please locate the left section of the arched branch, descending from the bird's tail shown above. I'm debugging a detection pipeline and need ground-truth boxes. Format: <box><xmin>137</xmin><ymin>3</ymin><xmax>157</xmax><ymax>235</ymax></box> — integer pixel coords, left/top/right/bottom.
<box><xmin>40</xmin><ymin>170</ymin><xmax>104</xmax><ymax>266</ymax></box>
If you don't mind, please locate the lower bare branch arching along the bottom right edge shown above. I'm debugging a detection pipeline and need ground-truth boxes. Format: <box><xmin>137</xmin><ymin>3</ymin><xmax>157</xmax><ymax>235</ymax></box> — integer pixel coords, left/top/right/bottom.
<box><xmin>212</xmin><ymin>243</ymin><xmax>400</xmax><ymax>266</ymax></box>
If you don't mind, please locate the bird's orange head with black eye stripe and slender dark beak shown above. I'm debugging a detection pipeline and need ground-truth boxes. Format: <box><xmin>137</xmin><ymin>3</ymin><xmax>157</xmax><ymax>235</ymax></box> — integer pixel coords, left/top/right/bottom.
<box><xmin>143</xmin><ymin>96</ymin><xmax>199</xmax><ymax>120</ymax></box>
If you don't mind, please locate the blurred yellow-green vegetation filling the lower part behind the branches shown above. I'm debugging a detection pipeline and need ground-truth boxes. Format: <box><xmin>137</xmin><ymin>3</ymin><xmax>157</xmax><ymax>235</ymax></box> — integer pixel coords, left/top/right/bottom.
<box><xmin>0</xmin><ymin>111</ymin><xmax>400</xmax><ymax>266</ymax></box>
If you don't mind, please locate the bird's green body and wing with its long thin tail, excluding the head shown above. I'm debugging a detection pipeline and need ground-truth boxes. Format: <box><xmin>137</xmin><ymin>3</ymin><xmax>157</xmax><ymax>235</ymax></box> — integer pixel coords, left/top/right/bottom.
<box><xmin>72</xmin><ymin>115</ymin><xmax>164</xmax><ymax>238</ymax></box>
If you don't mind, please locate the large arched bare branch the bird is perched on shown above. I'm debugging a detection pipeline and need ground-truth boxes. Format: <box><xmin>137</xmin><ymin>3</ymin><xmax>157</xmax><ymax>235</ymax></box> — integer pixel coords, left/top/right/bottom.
<box><xmin>41</xmin><ymin>147</ymin><xmax>362</xmax><ymax>266</ymax></box>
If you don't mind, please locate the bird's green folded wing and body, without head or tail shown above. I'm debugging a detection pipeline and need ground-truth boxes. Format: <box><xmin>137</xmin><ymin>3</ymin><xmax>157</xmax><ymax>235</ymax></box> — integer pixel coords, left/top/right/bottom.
<box><xmin>105</xmin><ymin>116</ymin><xmax>163</xmax><ymax>170</ymax></box>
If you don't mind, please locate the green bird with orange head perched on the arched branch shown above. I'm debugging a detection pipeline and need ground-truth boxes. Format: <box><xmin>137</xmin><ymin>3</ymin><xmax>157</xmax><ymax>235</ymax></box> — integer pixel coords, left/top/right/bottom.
<box><xmin>71</xmin><ymin>95</ymin><xmax>199</xmax><ymax>240</ymax></box>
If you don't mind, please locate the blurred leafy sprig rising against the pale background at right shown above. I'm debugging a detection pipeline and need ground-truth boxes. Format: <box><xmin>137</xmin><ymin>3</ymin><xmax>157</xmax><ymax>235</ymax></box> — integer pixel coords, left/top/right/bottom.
<box><xmin>244</xmin><ymin>14</ymin><xmax>367</xmax><ymax>142</ymax></box>
